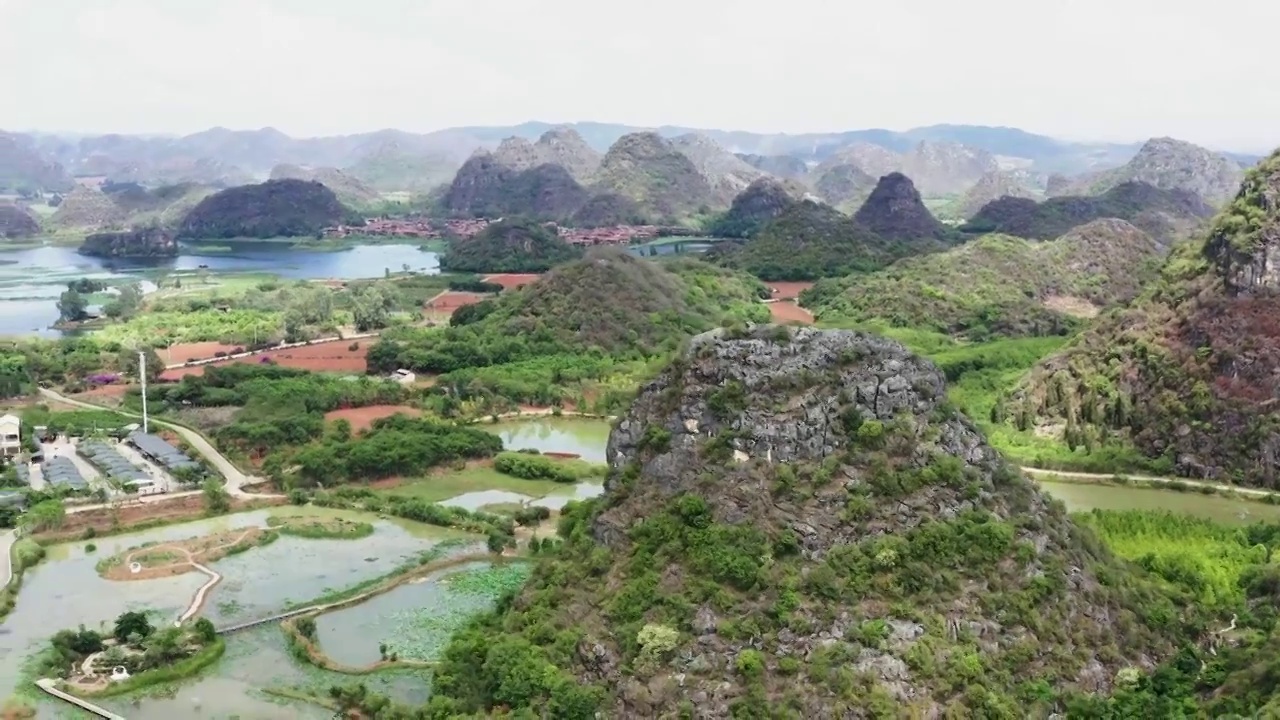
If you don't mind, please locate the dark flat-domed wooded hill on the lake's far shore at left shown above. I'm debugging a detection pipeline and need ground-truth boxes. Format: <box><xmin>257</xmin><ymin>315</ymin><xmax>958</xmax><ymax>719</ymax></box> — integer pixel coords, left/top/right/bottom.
<box><xmin>178</xmin><ymin>179</ymin><xmax>356</xmax><ymax>240</ymax></box>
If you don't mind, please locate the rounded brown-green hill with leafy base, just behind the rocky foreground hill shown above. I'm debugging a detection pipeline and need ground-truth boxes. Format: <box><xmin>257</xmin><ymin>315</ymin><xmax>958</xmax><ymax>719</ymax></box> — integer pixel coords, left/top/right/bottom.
<box><xmin>366</xmin><ymin>249</ymin><xmax>768</xmax><ymax>415</ymax></box>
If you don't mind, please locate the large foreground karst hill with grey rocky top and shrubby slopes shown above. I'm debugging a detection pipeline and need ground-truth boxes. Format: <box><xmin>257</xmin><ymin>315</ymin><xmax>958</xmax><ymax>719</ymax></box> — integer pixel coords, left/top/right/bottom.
<box><xmin>430</xmin><ymin>327</ymin><xmax>1169</xmax><ymax>720</ymax></box>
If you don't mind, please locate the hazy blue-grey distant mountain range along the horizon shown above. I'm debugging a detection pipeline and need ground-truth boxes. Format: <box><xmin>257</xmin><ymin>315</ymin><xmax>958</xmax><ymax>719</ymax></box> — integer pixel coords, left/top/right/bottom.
<box><xmin>0</xmin><ymin>122</ymin><xmax>1258</xmax><ymax>195</ymax></box>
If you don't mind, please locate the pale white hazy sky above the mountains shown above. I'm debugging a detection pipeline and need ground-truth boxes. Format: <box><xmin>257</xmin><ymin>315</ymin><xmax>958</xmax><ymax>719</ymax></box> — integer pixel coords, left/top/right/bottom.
<box><xmin>0</xmin><ymin>0</ymin><xmax>1280</xmax><ymax>151</ymax></box>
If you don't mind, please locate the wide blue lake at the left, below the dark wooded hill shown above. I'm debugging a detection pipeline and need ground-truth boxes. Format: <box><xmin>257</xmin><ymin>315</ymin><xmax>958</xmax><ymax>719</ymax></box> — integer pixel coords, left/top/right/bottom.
<box><xmin>0</xmin><ymin>241</ymin><xmax>440</xmax><ymax>337</ymax></box>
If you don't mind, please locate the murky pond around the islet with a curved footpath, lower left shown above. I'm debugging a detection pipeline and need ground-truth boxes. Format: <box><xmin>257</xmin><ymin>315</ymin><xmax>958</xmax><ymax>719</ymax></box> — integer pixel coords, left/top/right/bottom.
<box><xmin>0</xmin><ymin>507</ymin><xmax>471</xmax><ymax>720</ymax></box>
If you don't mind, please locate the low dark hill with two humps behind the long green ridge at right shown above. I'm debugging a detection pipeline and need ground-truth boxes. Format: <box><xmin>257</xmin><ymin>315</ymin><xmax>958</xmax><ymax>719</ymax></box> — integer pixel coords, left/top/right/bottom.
<box><xmin>961</xmin><ymin>182</ymin><xmax>1213</xmax><ymax>247</ymax></box>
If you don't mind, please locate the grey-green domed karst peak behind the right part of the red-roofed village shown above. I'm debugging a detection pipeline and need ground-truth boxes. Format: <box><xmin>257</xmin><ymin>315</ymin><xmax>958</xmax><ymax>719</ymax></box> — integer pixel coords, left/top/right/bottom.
<box><xmin>593</xmin><ymin>132</ymin><xmax>717</xmax><ymax>219</ymax></box>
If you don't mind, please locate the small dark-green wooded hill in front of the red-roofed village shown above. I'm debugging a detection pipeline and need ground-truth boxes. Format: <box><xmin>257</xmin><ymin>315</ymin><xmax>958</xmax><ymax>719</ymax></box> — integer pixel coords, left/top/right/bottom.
<box><xmin>440</xmin><ymin>215</ymin><xmax>582</xmax><ymax>273</ymax></box>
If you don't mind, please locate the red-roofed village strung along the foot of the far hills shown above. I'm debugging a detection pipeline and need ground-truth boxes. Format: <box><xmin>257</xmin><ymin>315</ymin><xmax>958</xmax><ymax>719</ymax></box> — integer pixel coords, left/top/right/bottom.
<box><xmin>324</xmin><ymin>218</ymin><xmax>696</xmax><ymax>246</ymax></box>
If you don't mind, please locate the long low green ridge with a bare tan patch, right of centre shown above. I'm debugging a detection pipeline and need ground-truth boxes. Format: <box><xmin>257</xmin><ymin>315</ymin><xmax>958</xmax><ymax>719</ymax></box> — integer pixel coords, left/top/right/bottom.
<box><xmin>803</xmin><ymin>220</ymin><xmax>1160</xmax><ymax>341</ymax></box>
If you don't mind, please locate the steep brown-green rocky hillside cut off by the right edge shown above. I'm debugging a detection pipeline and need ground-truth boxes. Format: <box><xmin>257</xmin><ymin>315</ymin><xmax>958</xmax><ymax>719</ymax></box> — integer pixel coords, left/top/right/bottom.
<box><xmin>1004</xmin><ymin>152</ymin><xmax>1280</xmax><ymax>488</ymax></box>
